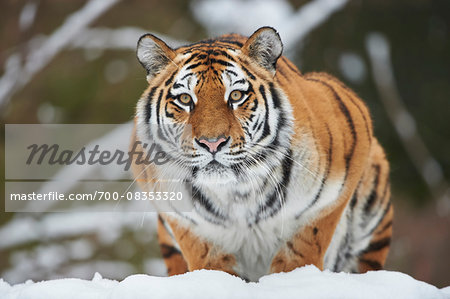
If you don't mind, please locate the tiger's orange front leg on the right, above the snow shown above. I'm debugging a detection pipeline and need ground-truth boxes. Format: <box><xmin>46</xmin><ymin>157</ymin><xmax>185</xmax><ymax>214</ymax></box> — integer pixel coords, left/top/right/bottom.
<box><xmin>270</xmin><ymin>201</ymin><xmax>347</xmax><ymax>273</ymax></box>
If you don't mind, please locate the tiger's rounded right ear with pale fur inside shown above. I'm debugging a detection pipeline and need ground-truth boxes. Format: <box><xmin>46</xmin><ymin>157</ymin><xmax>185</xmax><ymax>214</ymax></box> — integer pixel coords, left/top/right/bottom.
<box><xmin>242</xmin><ymin>27</ymin><xmax>283</xmax><ymax>74</ymax></box>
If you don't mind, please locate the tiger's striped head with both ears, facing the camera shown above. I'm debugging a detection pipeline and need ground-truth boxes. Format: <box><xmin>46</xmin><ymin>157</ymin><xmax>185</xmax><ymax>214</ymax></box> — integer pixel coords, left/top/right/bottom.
<box><xmin>137</xmin><ymin>27</ymin><xmax>292</xmax><ymax>188</ymax></box>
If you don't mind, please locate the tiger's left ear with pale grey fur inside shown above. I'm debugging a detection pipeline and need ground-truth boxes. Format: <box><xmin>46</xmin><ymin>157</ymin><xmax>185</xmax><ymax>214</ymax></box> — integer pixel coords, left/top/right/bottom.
<box><xmin>136</xmin><ymin>33</ymin><xmax>176</xmax><ymax>81</ymax></box>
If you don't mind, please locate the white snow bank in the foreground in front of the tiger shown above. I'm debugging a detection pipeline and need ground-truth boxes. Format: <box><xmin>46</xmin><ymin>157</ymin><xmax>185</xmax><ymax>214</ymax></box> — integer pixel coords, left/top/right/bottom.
<box><xmin>0</xmin><ymin>266</ymin><xmax>450</xmax><ymax>299</ymax></box>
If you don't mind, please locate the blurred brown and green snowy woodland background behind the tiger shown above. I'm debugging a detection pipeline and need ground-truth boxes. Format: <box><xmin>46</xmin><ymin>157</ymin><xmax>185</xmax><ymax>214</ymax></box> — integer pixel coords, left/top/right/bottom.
<box><xmin>0</xmin><ymin>0</ymin><xmax>450</xmax><ymax>287</ymax></box>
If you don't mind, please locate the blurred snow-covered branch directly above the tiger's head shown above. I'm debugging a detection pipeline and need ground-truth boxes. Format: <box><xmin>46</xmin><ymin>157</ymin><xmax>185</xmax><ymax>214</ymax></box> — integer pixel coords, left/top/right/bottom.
<box><xmin>191</xmin><ymin>0</ymin><xmax>348</xmax><ymax>52</ymax></box>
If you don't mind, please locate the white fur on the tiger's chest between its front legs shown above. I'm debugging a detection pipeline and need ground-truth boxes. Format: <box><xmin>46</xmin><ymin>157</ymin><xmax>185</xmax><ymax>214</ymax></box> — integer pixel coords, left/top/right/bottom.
<box><xmin>172</xmin><ymin>148</ymin><xmax>342</xmax><ymax>281</ymax></box>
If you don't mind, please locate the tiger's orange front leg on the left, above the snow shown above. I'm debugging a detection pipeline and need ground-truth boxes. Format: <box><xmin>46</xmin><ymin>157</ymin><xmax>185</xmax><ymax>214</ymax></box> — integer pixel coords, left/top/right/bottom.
<box><xmin>162</xmin><ymin>216</ymin><xmax>238</xmax><ymax>276</ymax></box>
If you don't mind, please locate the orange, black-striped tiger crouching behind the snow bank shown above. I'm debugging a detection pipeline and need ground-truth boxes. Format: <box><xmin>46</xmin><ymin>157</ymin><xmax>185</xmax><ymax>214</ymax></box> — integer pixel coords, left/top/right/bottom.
<box><xmin>131</xmin><ymin>27</ymin><xmax>394</xmax><ymax>281</ymax></box>
